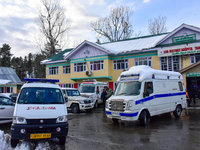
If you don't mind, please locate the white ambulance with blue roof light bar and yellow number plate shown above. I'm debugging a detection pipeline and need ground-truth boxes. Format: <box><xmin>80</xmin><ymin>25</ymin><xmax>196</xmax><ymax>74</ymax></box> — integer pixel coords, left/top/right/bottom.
<box><xmin>11</xmin><ymin>78</ymin><xmax>68</xmax><ymax>147</ymax></box>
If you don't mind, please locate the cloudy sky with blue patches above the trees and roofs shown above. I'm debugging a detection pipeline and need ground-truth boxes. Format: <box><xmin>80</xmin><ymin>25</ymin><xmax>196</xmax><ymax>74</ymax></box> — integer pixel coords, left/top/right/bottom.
<box><xmin>0</xmin><ymin>0</ymin><xmax>200</xmax><ymax>57</ymax></box>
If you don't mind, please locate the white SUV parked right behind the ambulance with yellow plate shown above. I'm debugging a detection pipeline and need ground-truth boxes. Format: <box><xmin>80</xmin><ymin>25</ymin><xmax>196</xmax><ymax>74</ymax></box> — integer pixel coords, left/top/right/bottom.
<box><xmin>62</xmin><ymin>88</ymin><xmax>94</xmax><ymax>113</ymax></box>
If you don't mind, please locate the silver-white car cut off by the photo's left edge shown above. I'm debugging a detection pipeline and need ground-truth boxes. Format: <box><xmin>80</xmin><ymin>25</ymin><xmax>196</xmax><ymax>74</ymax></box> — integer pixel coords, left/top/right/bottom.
<box><xmin>0</xmin><ymin>95</ymin><xmax>15</xmax><ymax>124</ymax></box>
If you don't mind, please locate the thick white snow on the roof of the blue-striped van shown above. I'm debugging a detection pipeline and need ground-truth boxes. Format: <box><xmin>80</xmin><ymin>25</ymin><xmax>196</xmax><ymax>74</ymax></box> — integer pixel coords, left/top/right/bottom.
<box><xmin>118</xmin><ymin>65</ymin><xmax>183</xmax><ymax>81</ymax></box>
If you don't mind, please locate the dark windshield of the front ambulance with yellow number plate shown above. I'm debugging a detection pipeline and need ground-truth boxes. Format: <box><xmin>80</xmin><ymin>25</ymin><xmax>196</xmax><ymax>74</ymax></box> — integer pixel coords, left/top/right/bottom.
<box><xmin>17</xmin><ymin>88</ymin><xmax>64</xmax><ymax>104</ymax></box>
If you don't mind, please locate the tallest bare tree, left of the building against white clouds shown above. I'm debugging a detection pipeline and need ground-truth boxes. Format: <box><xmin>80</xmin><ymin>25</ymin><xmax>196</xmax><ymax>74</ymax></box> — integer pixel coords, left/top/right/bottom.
<box><xmin>37</xmin><ymin>0</ymin><xmax>71</xmax><ymax>57</ymax></box>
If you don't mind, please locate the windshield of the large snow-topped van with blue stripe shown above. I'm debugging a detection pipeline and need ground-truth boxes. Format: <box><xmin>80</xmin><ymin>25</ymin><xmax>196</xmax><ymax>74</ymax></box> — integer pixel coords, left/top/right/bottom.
<box><xmin>114</xmin><ymin>81</ymin><xmax>141</xmax><ymax>96</ymax></box>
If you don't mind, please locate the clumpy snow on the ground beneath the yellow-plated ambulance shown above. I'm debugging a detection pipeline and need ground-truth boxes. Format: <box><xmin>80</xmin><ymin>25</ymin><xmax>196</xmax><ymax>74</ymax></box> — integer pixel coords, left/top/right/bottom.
<box><xmin>0</xmin><ymin>130</ymin><xmax>61</xmax><ymax>150</ymax></box>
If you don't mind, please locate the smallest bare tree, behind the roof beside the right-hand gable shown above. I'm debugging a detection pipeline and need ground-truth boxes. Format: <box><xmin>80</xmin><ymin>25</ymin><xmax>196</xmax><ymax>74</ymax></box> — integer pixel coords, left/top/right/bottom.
<box><xmin>149</xmin><ymin>16</ymin><xmax>167</xmax><ymax>35</ymax></box>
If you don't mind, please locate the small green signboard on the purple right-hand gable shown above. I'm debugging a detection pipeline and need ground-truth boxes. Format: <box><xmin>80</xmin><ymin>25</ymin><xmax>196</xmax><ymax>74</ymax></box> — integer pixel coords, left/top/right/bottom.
<box><xmin>172</xmin><ymin>34</ymin><xmax>196</xmax><ymax>43</ymax></box>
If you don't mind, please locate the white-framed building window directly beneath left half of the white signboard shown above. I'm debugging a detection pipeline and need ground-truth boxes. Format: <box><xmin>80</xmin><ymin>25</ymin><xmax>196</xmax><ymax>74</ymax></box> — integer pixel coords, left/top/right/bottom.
<box><xmin>160</xmin><ymin>56</ymin><xmax>180</xmax><ymax>71</ymax></box>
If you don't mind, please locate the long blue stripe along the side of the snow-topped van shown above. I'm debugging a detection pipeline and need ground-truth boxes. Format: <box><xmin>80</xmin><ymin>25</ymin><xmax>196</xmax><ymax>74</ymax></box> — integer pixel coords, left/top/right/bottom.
<box><xmin>135</xmin><ymin>92</ymin><xmax>186</xmax><ymax>105</ymax></box>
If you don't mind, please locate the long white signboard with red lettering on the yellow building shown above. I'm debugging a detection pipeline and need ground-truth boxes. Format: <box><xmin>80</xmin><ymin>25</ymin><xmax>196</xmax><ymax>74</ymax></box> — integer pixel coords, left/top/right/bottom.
<box><xmin>158</xmin><ymin>44</ymin><xmax>200</xmax><ymax>57</ymax></box>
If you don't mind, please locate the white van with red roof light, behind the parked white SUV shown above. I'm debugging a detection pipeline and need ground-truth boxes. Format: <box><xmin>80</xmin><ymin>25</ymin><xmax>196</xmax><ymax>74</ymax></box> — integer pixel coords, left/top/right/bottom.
<box><xmin>79</xmin><ymin>79</ymin><xmax>108</xmax><ymax>108</ymax></box>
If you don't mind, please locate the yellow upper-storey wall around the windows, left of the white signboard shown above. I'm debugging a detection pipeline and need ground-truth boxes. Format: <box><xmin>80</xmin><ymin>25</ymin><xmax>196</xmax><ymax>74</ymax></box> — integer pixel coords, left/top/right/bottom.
<box><xmin>46</xmin><ymin>52</ymin><xmax>160</xmax><ymax>84</ymax></box>
